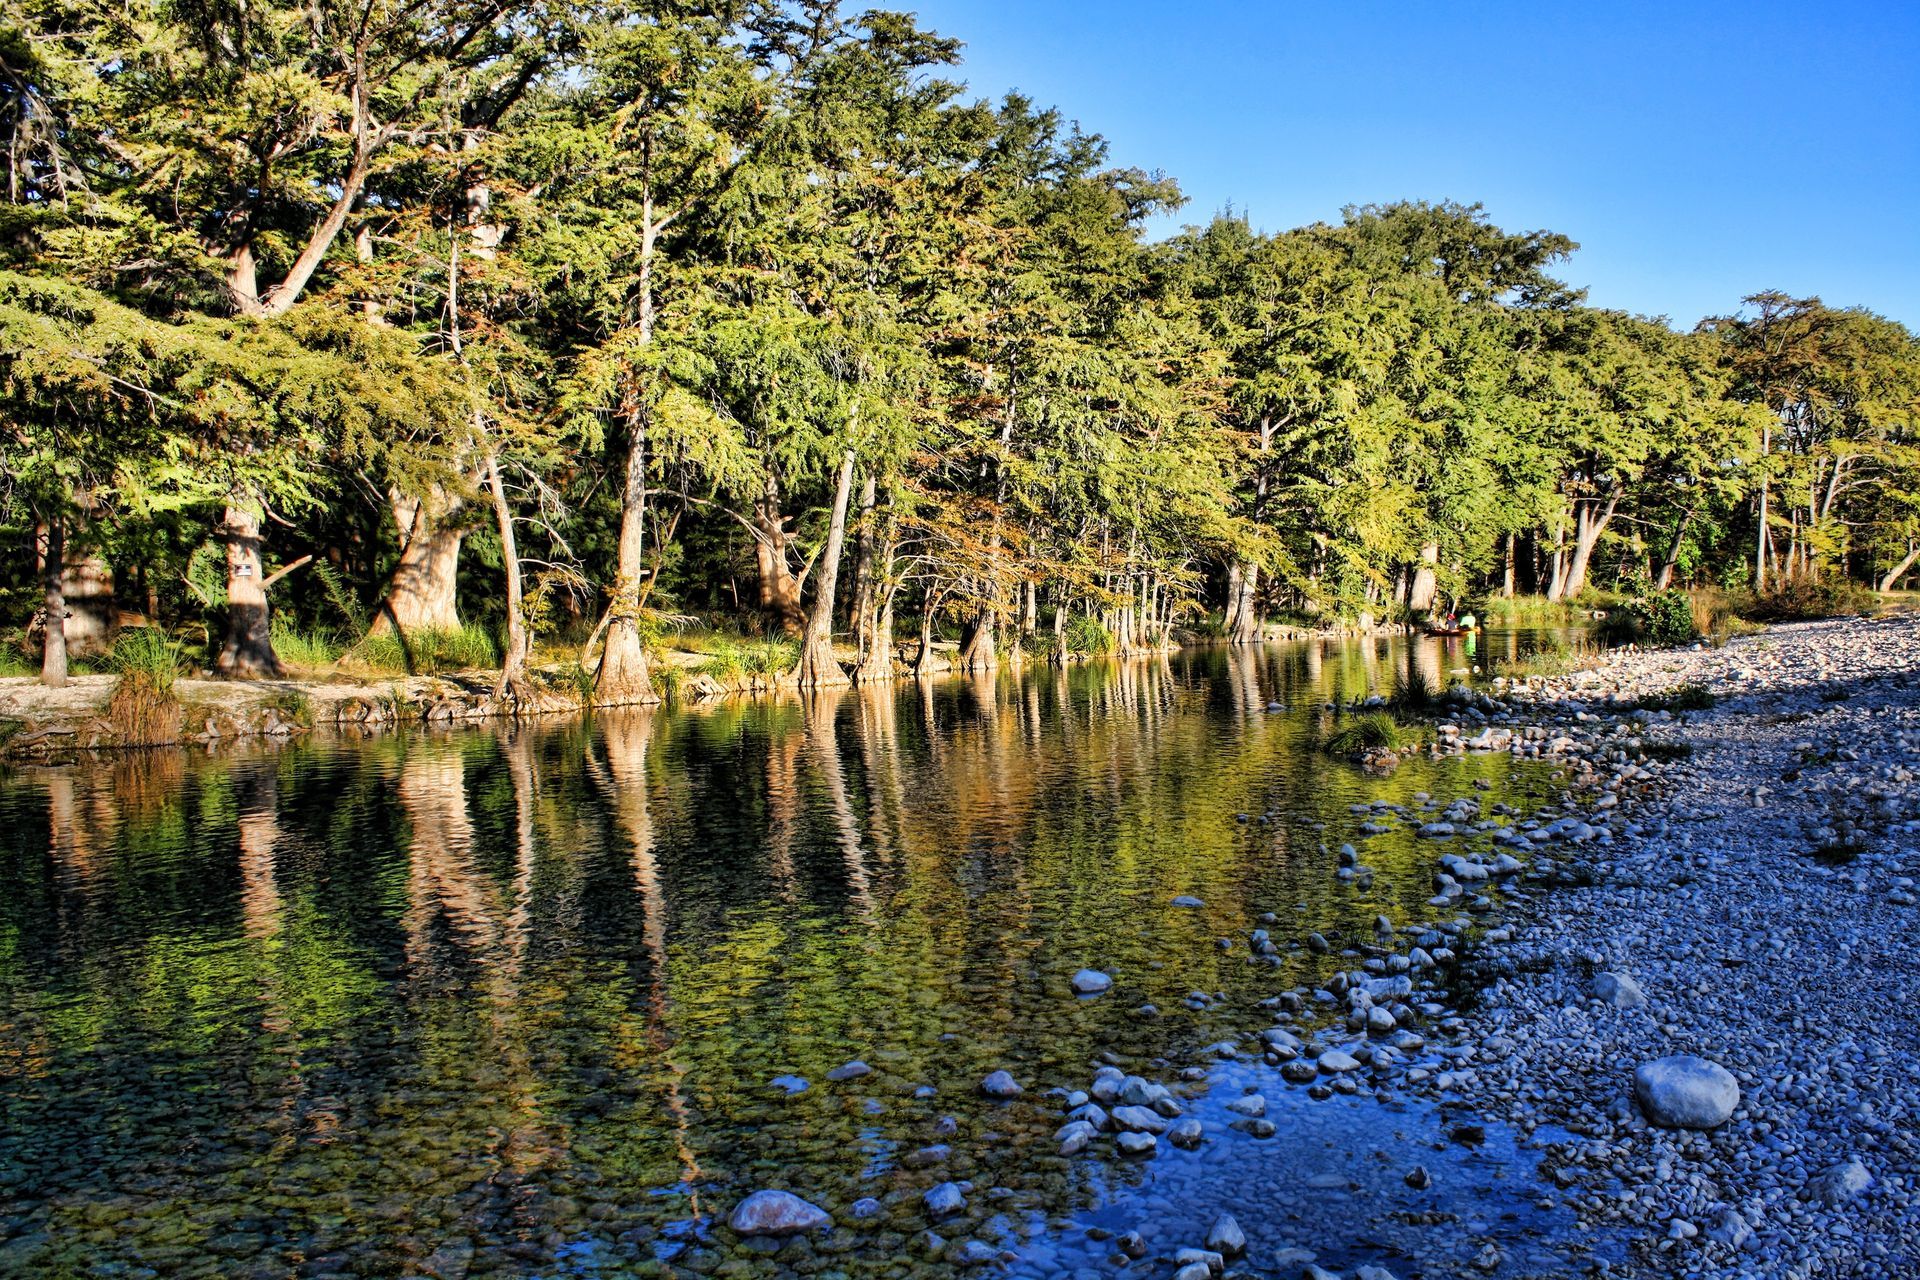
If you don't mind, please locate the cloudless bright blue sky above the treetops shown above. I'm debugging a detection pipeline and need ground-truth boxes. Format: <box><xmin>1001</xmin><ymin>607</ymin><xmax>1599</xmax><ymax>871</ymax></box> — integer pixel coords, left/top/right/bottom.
<box><xmin>895</xmin><ymin>0</ymin><xmax>1920</xmax><ymax>328</ymax></box>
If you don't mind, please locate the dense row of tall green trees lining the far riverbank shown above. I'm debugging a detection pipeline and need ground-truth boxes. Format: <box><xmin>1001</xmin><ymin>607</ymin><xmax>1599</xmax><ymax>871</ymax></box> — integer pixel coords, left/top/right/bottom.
<box><xmin>0</xmin><ymin>0</ymin><xmax>1920</xmax><ymax>702</ymax></box>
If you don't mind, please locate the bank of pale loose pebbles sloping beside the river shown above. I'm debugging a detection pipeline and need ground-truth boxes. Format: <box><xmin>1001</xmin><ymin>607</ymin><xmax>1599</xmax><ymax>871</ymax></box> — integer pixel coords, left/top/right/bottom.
<box><xmin>1434</xmin><ymin>618</ymin><xmax>1920</xmax><ymax>1280</ymax></box>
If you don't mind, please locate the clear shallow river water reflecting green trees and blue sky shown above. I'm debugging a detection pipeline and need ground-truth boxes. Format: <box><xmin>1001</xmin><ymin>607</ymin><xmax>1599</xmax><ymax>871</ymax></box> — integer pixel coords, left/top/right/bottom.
<box><xmin>0</xmin><ymin>641</ymin><xmax>1620</xmax><ymax>1280</ymax></box>
